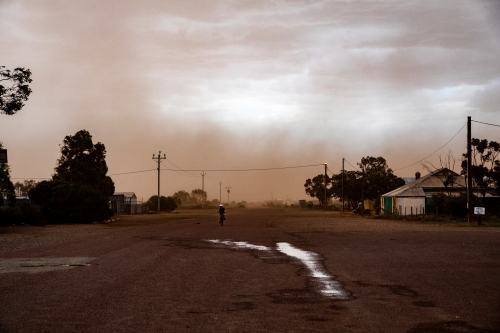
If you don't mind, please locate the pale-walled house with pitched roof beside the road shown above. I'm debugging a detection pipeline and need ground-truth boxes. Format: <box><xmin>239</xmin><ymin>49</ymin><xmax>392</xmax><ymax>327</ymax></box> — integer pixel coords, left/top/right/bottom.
<box><xmin>380</xmin><ymin>168</ymin><xmax>467</xmax><ymax>215</ymax></box>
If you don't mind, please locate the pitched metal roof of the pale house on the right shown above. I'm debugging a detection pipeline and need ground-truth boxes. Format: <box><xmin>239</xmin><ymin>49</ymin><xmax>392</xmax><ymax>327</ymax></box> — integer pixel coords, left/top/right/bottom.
<box><xmin>382</xmin><ymin>168</ymin><xmax>466</xmax><ymax>197</ymax></box>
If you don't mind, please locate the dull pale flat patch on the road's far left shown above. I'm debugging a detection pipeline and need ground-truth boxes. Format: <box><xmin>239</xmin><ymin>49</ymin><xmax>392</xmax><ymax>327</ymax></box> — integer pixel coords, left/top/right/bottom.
<box><xmin>0</xmin><ymin>257</ymin><xmax>95</xmax><ymax>273</ymax></box>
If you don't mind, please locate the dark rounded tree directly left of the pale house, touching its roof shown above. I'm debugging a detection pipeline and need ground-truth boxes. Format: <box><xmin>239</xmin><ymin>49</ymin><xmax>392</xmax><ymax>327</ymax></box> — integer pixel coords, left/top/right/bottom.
<box><xmin>358</xmin><ymin>156</ymin><xmax>405</xmax><ymax>200</ymax></box>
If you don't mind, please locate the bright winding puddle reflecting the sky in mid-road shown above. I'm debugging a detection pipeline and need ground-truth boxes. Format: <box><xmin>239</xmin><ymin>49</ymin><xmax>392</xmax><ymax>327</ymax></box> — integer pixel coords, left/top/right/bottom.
<box><xmin>207</xmin><ymin>239</ymin><xmax>350</xmax><ymax>300</ymax></box>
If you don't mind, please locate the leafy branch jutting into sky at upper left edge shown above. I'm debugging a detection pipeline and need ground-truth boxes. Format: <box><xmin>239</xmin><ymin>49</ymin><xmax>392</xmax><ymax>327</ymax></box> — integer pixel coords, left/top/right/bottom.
<box><xmin>0</xmin><ymin>66</ymin><xmax>32</xmax><ymax>116</ymax></box>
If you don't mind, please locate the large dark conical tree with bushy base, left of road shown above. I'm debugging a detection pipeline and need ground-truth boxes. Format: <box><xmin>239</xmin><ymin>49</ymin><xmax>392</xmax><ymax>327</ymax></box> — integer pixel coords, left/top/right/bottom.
<box><xmin>28</xmin><ymin>130</ymin><xmax>115</xmax><ymax>223</ymax></box>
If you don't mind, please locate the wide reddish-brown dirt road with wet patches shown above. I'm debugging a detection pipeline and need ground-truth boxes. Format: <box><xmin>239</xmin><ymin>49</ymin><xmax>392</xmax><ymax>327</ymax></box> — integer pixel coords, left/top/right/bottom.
<box><xmin>0</xmin><ymin>209</ymin><xmax>500</xmax><ymax>333</ymax></box>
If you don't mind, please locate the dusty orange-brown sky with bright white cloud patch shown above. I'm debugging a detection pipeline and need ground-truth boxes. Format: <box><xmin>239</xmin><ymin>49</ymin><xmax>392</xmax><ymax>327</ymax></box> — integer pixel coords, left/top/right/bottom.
<box><xmin>0</xmin><ymin>0</ymin><xmax>500</xmax><ymax>202</ymax></box>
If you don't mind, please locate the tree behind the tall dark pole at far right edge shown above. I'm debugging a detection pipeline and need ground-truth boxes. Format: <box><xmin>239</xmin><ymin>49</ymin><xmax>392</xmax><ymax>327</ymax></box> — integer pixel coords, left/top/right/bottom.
<box><xmin>462</xmin><ymin>138</ymin><xmax>500</xmax><ymax>198</ymax></box>
